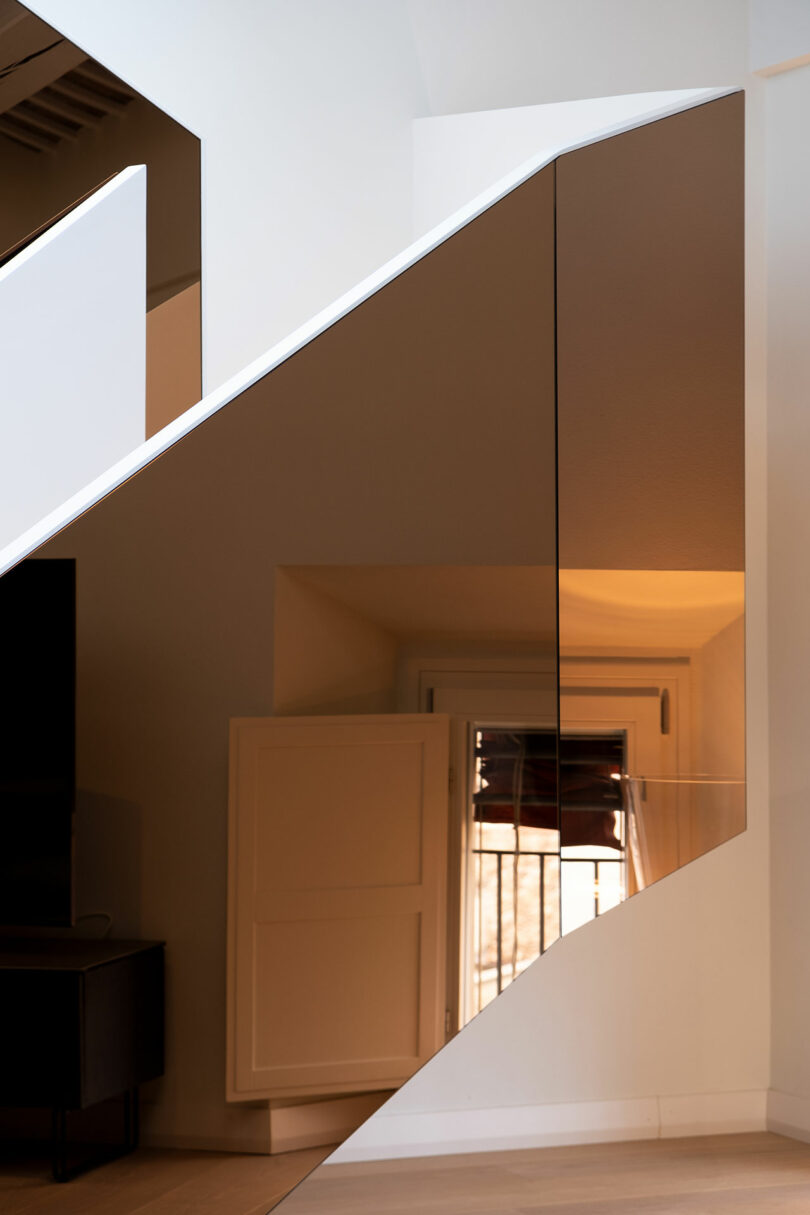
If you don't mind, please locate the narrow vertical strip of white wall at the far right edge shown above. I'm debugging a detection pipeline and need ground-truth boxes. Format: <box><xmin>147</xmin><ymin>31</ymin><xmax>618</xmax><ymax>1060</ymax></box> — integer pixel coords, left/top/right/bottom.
<box><xmin>766</xmin><ymin>57</ymin><xmax>810</xmax><ymax>1135</ymax></box>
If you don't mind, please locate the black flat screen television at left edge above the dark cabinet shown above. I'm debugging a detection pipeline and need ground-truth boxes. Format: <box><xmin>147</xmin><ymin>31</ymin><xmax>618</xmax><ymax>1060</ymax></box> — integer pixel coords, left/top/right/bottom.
<box><xmin>0</xmin><ymin>558</ymin><xmax>75</xmax><ymax>926</ymax></box>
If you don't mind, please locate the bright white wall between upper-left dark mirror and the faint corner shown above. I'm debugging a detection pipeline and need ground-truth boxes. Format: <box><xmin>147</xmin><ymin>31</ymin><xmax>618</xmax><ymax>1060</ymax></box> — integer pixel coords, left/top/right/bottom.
<box><xmin>29</xmin><ymin>0</ymin><xmax>427</xmax><ymax>391</ymax></box>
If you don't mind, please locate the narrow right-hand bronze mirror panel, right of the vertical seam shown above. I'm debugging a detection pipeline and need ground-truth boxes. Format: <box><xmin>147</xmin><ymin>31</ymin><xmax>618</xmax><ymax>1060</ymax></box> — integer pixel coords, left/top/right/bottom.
<box><xmin>557</xmin><ymin>95</ymin><xmax>744</xmax><ymax>894</ymax></box>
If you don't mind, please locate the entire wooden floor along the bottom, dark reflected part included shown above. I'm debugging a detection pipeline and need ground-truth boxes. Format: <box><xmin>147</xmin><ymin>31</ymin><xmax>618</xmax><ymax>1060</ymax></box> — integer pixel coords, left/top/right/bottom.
<box><xmin>0</xmin><ymin>1134</ymin><xmax>810</xmax><ymax>1215</ymax></box>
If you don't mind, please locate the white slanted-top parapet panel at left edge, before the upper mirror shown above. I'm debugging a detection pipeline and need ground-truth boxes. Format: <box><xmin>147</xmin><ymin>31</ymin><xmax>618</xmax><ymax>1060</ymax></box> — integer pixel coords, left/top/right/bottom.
<box><xmin>0</xmin><ymin>166</ymin><xmax>146</xmax><ymax>547</ymax></box>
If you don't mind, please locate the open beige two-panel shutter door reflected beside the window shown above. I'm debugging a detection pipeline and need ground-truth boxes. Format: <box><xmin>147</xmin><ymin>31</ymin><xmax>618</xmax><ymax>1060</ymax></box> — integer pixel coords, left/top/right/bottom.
<box><xmin>227</xmin><ymin>714</ymin><xmax>448</xmax><ymax>1101</ymax></box>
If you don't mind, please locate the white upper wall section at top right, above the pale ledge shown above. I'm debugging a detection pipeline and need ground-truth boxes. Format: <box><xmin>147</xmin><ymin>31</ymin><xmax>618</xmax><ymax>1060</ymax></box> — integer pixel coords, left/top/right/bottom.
<box><xmin>408</xmin><ymin>0</ymin><xmax>748</xmax><ymax>114</ymax></box>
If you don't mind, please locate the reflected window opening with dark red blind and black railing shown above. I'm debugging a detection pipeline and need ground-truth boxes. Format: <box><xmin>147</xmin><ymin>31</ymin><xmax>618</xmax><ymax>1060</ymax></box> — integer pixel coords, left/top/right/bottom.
<box><xmin>471</xmin><ymin>727</ymin><xmax>625</xmax><ymax>1011</ymax></box>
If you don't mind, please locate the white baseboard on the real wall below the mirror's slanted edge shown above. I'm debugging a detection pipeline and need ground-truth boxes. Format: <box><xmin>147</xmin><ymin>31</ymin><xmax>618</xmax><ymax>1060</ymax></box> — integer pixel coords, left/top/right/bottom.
<box><xmin>329</xmin><ymin>1090</ymin><xmax>766</xmax><ymax>1165</ymax></box>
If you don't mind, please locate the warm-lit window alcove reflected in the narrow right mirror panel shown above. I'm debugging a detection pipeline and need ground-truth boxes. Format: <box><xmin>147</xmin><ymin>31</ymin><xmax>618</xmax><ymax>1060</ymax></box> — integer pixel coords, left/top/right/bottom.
<box><xmin>560</xmin><ymin>570</ymin><xmax>746</xmax><ymax>894</ymax></box>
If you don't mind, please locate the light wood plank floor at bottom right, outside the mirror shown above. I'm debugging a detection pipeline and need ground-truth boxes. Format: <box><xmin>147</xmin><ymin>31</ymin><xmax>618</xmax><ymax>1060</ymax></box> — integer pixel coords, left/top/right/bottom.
<box><xmin>276</xmin><ymin>1134</ymin><xmax>810</xmax><ymax>1215</ymax></box>
